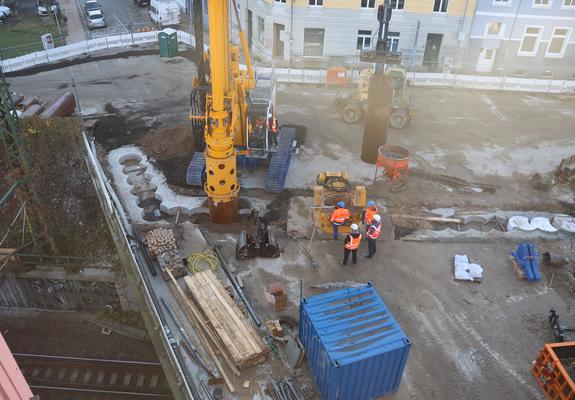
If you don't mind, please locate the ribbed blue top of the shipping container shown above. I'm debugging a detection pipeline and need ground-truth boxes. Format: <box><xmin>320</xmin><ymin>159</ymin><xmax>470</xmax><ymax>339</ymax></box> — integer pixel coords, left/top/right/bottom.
<box><xmin>301</xmin><ymin>283</ymin><xmax>409</xmax><ymax>366</ymax></box>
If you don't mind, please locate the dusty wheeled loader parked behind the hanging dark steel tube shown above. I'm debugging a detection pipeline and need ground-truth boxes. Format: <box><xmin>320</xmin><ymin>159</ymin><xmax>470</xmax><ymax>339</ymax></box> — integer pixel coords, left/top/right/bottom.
<box><xmin>333</xmin><ymin>66</ymin><xmax>413</xmax><ymax>129</ymax></box>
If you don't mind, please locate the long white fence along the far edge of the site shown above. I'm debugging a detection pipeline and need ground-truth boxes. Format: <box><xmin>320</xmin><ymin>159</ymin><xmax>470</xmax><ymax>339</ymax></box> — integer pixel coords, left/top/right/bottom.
<box><xmin>0</xmin><ymin>31</ymin><xmax>575</xmax><ymax>95</ymax></box>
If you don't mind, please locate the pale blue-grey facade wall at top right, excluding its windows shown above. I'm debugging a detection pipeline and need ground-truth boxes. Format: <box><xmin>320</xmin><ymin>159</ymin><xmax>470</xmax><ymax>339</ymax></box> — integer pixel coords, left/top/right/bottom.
<box><xmin>465</xmin><ymin>0</ymin><xmax>575</xmax><ymax>78</ymax></box>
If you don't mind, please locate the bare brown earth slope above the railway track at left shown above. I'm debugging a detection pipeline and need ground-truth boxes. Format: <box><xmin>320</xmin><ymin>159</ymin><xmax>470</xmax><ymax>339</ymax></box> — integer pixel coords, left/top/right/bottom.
<box><xmin>22</xmin><ymin>118</ymin><xmax>114</xmax><ymax>256</ymax></box>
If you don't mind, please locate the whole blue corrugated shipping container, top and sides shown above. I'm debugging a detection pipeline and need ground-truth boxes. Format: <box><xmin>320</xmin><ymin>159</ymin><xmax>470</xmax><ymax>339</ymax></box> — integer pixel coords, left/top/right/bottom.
<box><xmin>299</xmin><ymin>284</ymin><xmax>411</xmax><ymax>400</ymax></box>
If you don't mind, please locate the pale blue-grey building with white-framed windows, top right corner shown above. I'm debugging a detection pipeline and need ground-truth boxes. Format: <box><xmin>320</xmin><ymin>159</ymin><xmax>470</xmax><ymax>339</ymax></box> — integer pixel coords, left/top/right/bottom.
<box><xmin>464</xmin><ymin>0</ymin><xmax>575</xmax><ymax>78</ymax></box>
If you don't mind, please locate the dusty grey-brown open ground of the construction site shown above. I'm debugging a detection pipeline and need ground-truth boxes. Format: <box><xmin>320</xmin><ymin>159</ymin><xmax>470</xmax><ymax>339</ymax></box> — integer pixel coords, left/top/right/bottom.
<box><xmin>4</xmin><ymin>56</ymin><xmax>575</xmax><ymax>400</ymax></box>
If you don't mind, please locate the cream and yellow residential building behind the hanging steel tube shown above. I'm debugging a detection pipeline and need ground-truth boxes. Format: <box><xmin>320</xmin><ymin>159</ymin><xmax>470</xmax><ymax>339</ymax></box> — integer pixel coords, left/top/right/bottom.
<box><xmin>234</xmin><ymin>0</ymin><xmax>476</xmax><ymax>70</ymax></box>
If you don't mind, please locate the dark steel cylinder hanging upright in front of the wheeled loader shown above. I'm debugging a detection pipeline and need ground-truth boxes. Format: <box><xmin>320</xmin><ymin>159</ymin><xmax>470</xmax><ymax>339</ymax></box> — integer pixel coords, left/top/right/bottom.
<box><xmin>361</xmin><ymin>73</ymin><xmax>393</xmax><ymax>164</ymax></box>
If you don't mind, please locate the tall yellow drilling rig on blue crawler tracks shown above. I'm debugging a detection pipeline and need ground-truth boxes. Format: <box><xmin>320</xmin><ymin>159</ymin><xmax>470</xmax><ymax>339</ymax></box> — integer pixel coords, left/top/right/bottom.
<box><xmin>186</xmin><ymin>0</ymin><xmax>296</xmax><ymax>224</ymax></box>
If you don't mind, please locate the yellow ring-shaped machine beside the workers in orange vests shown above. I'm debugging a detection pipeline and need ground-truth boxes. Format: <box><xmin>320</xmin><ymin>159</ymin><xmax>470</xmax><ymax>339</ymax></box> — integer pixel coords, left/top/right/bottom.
<box><xmin>313</xmin><ymin>171</ymin><xmax>367</xmax><ymax>234</ymax></box>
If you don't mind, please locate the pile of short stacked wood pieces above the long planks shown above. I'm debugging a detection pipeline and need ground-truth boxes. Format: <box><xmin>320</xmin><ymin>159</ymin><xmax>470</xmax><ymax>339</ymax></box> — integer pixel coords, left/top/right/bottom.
<box><xmin>144</xmin><ymin>228</ymin><xmax>187</xmax><ymax>281</ymax></box>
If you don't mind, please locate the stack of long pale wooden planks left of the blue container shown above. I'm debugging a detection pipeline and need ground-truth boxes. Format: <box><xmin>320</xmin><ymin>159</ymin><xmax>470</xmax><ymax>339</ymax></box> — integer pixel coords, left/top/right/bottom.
<box><xmin>184</xmin><ymin>270</ymin><xmax>269</xmax><ymax>369</ymax></box>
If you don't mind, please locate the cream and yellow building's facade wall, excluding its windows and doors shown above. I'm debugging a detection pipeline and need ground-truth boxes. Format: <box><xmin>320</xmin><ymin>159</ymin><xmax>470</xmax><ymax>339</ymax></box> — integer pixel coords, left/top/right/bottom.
<box><xmin>240</xmin><ymin>0</ymin><xmax>475</xmax><ymax>66</ymax></box>
